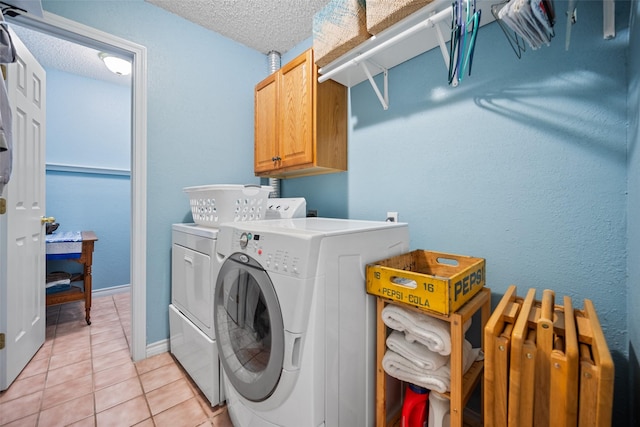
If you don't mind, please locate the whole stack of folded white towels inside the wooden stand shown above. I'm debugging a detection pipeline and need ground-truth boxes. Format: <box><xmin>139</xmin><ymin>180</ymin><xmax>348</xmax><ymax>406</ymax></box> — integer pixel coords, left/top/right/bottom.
<box><xmin>382</xmin><ymin>305</ymin><xmax>482</xmax><ymax>393</ymax></box>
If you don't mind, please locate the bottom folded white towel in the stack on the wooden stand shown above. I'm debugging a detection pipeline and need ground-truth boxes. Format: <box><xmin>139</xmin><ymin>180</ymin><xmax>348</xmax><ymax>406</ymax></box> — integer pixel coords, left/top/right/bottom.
<box><xmin>382</xmin><ymin>340</ymin><xmax>481</xmax><ymax>393</ymax></box>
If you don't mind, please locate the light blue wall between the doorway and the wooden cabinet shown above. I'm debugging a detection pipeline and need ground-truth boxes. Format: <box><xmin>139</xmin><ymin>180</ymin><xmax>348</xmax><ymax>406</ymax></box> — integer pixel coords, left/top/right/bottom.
<box><xmin>42</xmin><ymin>0</ymin><xmax>267</xmax><ymax>343</ymax></box>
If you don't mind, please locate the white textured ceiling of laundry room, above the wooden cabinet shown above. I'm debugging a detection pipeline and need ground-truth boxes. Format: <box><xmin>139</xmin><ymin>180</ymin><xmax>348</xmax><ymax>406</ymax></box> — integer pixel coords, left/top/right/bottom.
<box><xmin>145</xmin><ymin>0</ymin><xmax>329</xmax><ymax>54</ymax></box>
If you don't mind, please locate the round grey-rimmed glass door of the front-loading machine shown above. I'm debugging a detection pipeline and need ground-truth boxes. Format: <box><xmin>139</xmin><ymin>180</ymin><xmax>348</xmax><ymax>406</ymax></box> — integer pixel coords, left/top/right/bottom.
<box><xmin>214</xmin><ymin>252</ymin><xmax>284</xmax><ymax>402</ymax></box>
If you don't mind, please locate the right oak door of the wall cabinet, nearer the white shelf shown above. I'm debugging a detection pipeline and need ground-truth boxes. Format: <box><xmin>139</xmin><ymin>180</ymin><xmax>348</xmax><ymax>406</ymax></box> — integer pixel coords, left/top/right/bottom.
<box><xmin>278</xmin><ymin>49</ymin><xmax>315</xmax><ymax>167</ymax></box>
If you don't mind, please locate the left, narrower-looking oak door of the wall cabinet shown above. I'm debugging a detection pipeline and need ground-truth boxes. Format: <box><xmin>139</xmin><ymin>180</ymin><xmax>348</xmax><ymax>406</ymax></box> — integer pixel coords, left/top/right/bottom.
<box><xmin>253</xmin><ymin>73</ymin><xmax>279</xmax><ymax>173</ymax></box>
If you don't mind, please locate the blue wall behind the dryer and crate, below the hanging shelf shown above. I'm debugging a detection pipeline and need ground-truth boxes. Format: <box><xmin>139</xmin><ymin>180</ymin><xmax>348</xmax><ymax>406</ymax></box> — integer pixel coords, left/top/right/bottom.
<box><xmin>281</xmin><ymin>1</ymin><xmax>640</xmax><ymax>425</ymax></box>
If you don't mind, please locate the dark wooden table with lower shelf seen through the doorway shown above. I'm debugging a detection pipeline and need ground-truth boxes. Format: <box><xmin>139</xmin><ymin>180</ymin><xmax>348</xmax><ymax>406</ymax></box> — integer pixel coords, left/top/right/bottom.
<box><xmin>47</xmin><ymin>231</ymin><xmax>98</xmax><ymax>325</ymax></box>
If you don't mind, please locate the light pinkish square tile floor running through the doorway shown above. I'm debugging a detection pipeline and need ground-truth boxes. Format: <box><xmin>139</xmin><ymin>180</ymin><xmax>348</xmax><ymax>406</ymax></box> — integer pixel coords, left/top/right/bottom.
<box><xmin>0</xmin><ymin>293</ymin><xmax>232</xmax><ymax>427</ymax></box>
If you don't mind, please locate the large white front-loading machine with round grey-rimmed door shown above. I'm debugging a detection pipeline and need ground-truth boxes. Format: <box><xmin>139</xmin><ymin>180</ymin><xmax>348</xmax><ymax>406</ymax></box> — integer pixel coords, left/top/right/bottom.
<box><xmin>214</xmin><ymin>218</ymin><xmax>409</xmax><ymax>427</ymax></box>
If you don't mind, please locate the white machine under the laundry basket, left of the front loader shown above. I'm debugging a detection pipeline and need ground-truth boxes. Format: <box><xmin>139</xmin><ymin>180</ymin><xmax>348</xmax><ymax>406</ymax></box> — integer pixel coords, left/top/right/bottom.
<box><xmin>169</xmin><ymin>224</ymin><xmax>224</xmax><ymax>406</ymax></box>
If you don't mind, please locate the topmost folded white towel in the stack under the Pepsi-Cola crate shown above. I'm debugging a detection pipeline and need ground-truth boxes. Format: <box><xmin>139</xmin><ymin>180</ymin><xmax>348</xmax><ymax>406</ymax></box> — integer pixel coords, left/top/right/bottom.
<box><xmin>382</xmin><ymin>304</ymin><xmax>471</xmax><ymax>356</ymax></box>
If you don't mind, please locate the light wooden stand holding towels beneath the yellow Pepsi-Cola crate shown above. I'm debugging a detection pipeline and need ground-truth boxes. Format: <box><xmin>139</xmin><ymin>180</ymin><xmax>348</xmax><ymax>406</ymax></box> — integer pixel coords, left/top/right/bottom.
<box><xmin>376</xmin><ymin>288</ymin><xmax>491</xmax><ymax>427</ymax></box>
